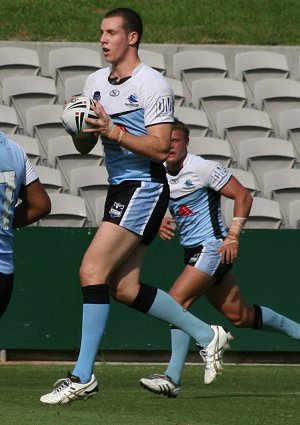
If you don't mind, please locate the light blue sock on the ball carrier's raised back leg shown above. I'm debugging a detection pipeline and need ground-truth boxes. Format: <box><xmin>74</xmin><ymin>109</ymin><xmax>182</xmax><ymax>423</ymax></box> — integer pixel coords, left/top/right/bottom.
<box><xmin>148</xmin><ymin>289</ymin><xmax>214</xmax><ymax>348</ymax></box>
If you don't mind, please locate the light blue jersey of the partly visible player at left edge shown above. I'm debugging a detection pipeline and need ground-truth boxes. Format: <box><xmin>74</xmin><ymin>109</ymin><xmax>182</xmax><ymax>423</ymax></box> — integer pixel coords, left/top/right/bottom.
<box><xmin>0</xmin><ymin>132</ymin><xmax>38</xmax><ymax>274</ymax></box>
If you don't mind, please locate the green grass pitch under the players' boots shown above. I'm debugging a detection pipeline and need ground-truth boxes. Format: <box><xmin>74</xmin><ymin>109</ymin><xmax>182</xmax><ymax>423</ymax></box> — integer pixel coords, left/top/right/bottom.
<box><xmin>0</xmin><ymin>364</ymin><xmax>300</xmax><ymax>425</ymax></box>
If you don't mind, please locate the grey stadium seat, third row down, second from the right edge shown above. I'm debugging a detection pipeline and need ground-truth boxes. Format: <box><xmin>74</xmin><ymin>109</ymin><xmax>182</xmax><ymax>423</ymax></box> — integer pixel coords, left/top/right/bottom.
<box><xmin>217</xmin><ymin>108</ymin><xmax>273</xmax><ymax>160</ymax></box>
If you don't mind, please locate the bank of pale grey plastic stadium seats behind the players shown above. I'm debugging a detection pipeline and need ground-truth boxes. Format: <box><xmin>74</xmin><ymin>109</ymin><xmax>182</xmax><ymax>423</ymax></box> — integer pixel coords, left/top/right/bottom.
<box><xmin>0</xmin><ymin>47</ymin><xmax>300</xmax><ymax>228</ymax></box>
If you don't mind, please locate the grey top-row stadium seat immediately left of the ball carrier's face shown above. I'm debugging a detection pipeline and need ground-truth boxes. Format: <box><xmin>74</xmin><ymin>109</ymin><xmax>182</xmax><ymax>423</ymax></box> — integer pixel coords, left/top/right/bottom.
<box><xmin>48</xmin><ymin>47</ymin><xmax>103</xmax><ymax>104</ymax></box>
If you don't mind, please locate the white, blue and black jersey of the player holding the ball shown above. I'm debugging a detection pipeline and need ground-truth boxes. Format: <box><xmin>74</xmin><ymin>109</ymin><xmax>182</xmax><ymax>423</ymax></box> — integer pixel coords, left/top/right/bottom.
<box><xmin>83</xmin><ymin>64</ymin><xmax>174</xmax><ymax>184</ymax></box>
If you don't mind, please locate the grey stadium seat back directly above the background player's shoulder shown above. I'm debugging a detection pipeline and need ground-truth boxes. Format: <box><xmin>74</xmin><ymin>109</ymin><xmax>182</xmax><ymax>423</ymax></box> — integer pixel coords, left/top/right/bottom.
<box><xmin>188</xmin><ymin>137</ymin><xmax>232</xmax><ymax>167</ymax></box>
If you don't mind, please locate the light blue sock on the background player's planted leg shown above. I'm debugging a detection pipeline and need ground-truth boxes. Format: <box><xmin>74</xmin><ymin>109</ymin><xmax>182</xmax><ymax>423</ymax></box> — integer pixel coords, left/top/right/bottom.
<box><xmin>165</xmin><ymin>328</ymin><xmax>191</xmax><ymax>385</ymax></box>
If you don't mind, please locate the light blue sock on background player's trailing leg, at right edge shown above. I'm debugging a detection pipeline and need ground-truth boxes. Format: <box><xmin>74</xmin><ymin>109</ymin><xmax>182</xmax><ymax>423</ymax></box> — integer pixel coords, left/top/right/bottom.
<box><xmin>260</xmin><ymin>306</ymin><xmax>300</xmax><ymax>340</ymax></box>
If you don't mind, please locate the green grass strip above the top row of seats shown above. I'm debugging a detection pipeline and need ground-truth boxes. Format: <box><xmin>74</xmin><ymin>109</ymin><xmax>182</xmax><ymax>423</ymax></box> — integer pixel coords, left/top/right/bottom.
<box><xmin>0</xmin><ymin>0</ymin><xmax>300</xmax><ymax>46</ymax></box>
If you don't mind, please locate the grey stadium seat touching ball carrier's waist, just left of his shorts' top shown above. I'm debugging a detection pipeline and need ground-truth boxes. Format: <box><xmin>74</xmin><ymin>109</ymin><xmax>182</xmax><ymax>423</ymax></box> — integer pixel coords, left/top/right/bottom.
<box><xmin>70</xmin><ymin>166</ymin><xmax>108</xmax><ymax>226</ymax></box>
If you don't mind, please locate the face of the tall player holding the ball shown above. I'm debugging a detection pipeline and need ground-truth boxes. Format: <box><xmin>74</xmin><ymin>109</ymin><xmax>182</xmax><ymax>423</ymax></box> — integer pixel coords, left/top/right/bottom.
<box><xmin>100</xmin><ymin>16</ymin><xmax>130</xmax><ymax>64</ymax></box>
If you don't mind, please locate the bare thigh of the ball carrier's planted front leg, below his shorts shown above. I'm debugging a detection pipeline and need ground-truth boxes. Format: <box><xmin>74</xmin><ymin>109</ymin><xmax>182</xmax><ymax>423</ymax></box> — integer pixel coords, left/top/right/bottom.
<box><xmin>80</xmin><ymin>221</ymin><xmax>141</xmax><ymax>284</ymax></box>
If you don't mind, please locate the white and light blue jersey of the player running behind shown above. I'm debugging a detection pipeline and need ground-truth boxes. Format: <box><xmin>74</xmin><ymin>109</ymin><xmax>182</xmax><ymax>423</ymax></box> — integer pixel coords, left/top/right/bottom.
<box><xmin>167</xmin><ymin>154</ymin><xmax>231</xmax><ymax>248</ymax></box>
